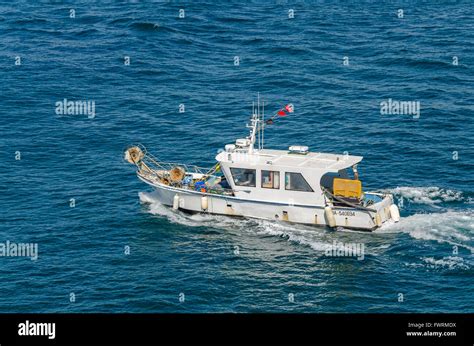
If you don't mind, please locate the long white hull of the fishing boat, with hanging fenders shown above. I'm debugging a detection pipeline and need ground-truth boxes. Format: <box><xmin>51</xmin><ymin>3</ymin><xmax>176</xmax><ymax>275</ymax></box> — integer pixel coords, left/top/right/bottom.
<box><xmin>139</xmin><ymin>176</ymin><xmax>393</xmax><ymax>231</ymax></box>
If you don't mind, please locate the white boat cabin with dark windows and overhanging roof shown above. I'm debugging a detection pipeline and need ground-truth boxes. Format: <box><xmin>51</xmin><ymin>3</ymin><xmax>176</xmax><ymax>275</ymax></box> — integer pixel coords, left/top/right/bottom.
<box><xmin>216</xmin><ymin>144</ymin><xmax>362</xmax><ymax>205</ymax></box>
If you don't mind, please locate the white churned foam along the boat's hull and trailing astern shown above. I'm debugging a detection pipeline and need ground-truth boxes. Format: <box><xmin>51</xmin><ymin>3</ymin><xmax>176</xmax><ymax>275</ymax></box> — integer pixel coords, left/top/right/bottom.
<box><xmin>139</xmin><ymin>192</ymin><xmax>474</xmax><ymax>253</ymax></box>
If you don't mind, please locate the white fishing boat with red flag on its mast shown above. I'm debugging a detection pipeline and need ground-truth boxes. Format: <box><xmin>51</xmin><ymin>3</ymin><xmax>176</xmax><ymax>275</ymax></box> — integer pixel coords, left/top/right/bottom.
<box><xmin>125</xmin><ymin>96</ymin><xmax>400</xmax><ymax>231</ymax></box>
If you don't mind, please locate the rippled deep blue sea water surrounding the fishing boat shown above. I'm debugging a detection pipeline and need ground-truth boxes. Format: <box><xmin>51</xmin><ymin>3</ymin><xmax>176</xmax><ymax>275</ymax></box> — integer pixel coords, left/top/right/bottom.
<box><xmin>0</xmin><ymin>1</ymin><xmax>474</xmax><ymax>313</ymax></box>
